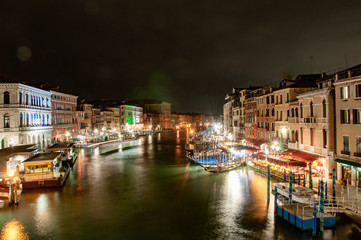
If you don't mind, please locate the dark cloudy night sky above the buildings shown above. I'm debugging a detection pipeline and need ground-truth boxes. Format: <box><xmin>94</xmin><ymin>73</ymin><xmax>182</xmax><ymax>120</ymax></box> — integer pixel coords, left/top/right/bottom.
<box><xmin>0</xmin><ymin>0</ymin><xmax>361</xmax><ymax>114</ymax></box>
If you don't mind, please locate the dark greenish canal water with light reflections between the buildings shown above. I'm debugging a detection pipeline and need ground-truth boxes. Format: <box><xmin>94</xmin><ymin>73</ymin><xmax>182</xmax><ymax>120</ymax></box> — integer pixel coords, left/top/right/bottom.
<box><xmin>0</xmin><ymin>132</ymin><xmax>360</xmax><ymax>240</ymax></box>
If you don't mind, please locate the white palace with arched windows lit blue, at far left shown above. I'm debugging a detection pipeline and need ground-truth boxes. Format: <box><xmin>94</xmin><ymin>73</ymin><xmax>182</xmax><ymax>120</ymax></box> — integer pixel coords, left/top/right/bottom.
<box><xmin>0</xmin><ymin>83</ymin><xmax>53</xmax><ymax>149</ymax></box>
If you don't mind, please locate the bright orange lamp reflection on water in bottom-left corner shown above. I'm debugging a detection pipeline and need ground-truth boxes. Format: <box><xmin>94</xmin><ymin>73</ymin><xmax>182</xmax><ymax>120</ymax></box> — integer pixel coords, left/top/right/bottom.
<box><xmin>0</xmin><ymin>219</ymin><xmax>29</xmax><ymax>240</ymax></box>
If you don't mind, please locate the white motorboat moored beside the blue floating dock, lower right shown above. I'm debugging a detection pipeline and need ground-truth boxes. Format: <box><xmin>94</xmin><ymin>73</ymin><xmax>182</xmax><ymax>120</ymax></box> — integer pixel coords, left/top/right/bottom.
<box><xmin>272</xmin><ymin>183</ymin><xmax>315</xmax><ymax>204</ymax></box>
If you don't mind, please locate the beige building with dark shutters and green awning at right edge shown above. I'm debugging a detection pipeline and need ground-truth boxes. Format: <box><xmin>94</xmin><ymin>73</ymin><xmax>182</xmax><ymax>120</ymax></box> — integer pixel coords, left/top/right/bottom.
<box><xmin>334</xmin><ymin>65</ymin><xmax>361</xmax><ymax>186</ymax></box>
